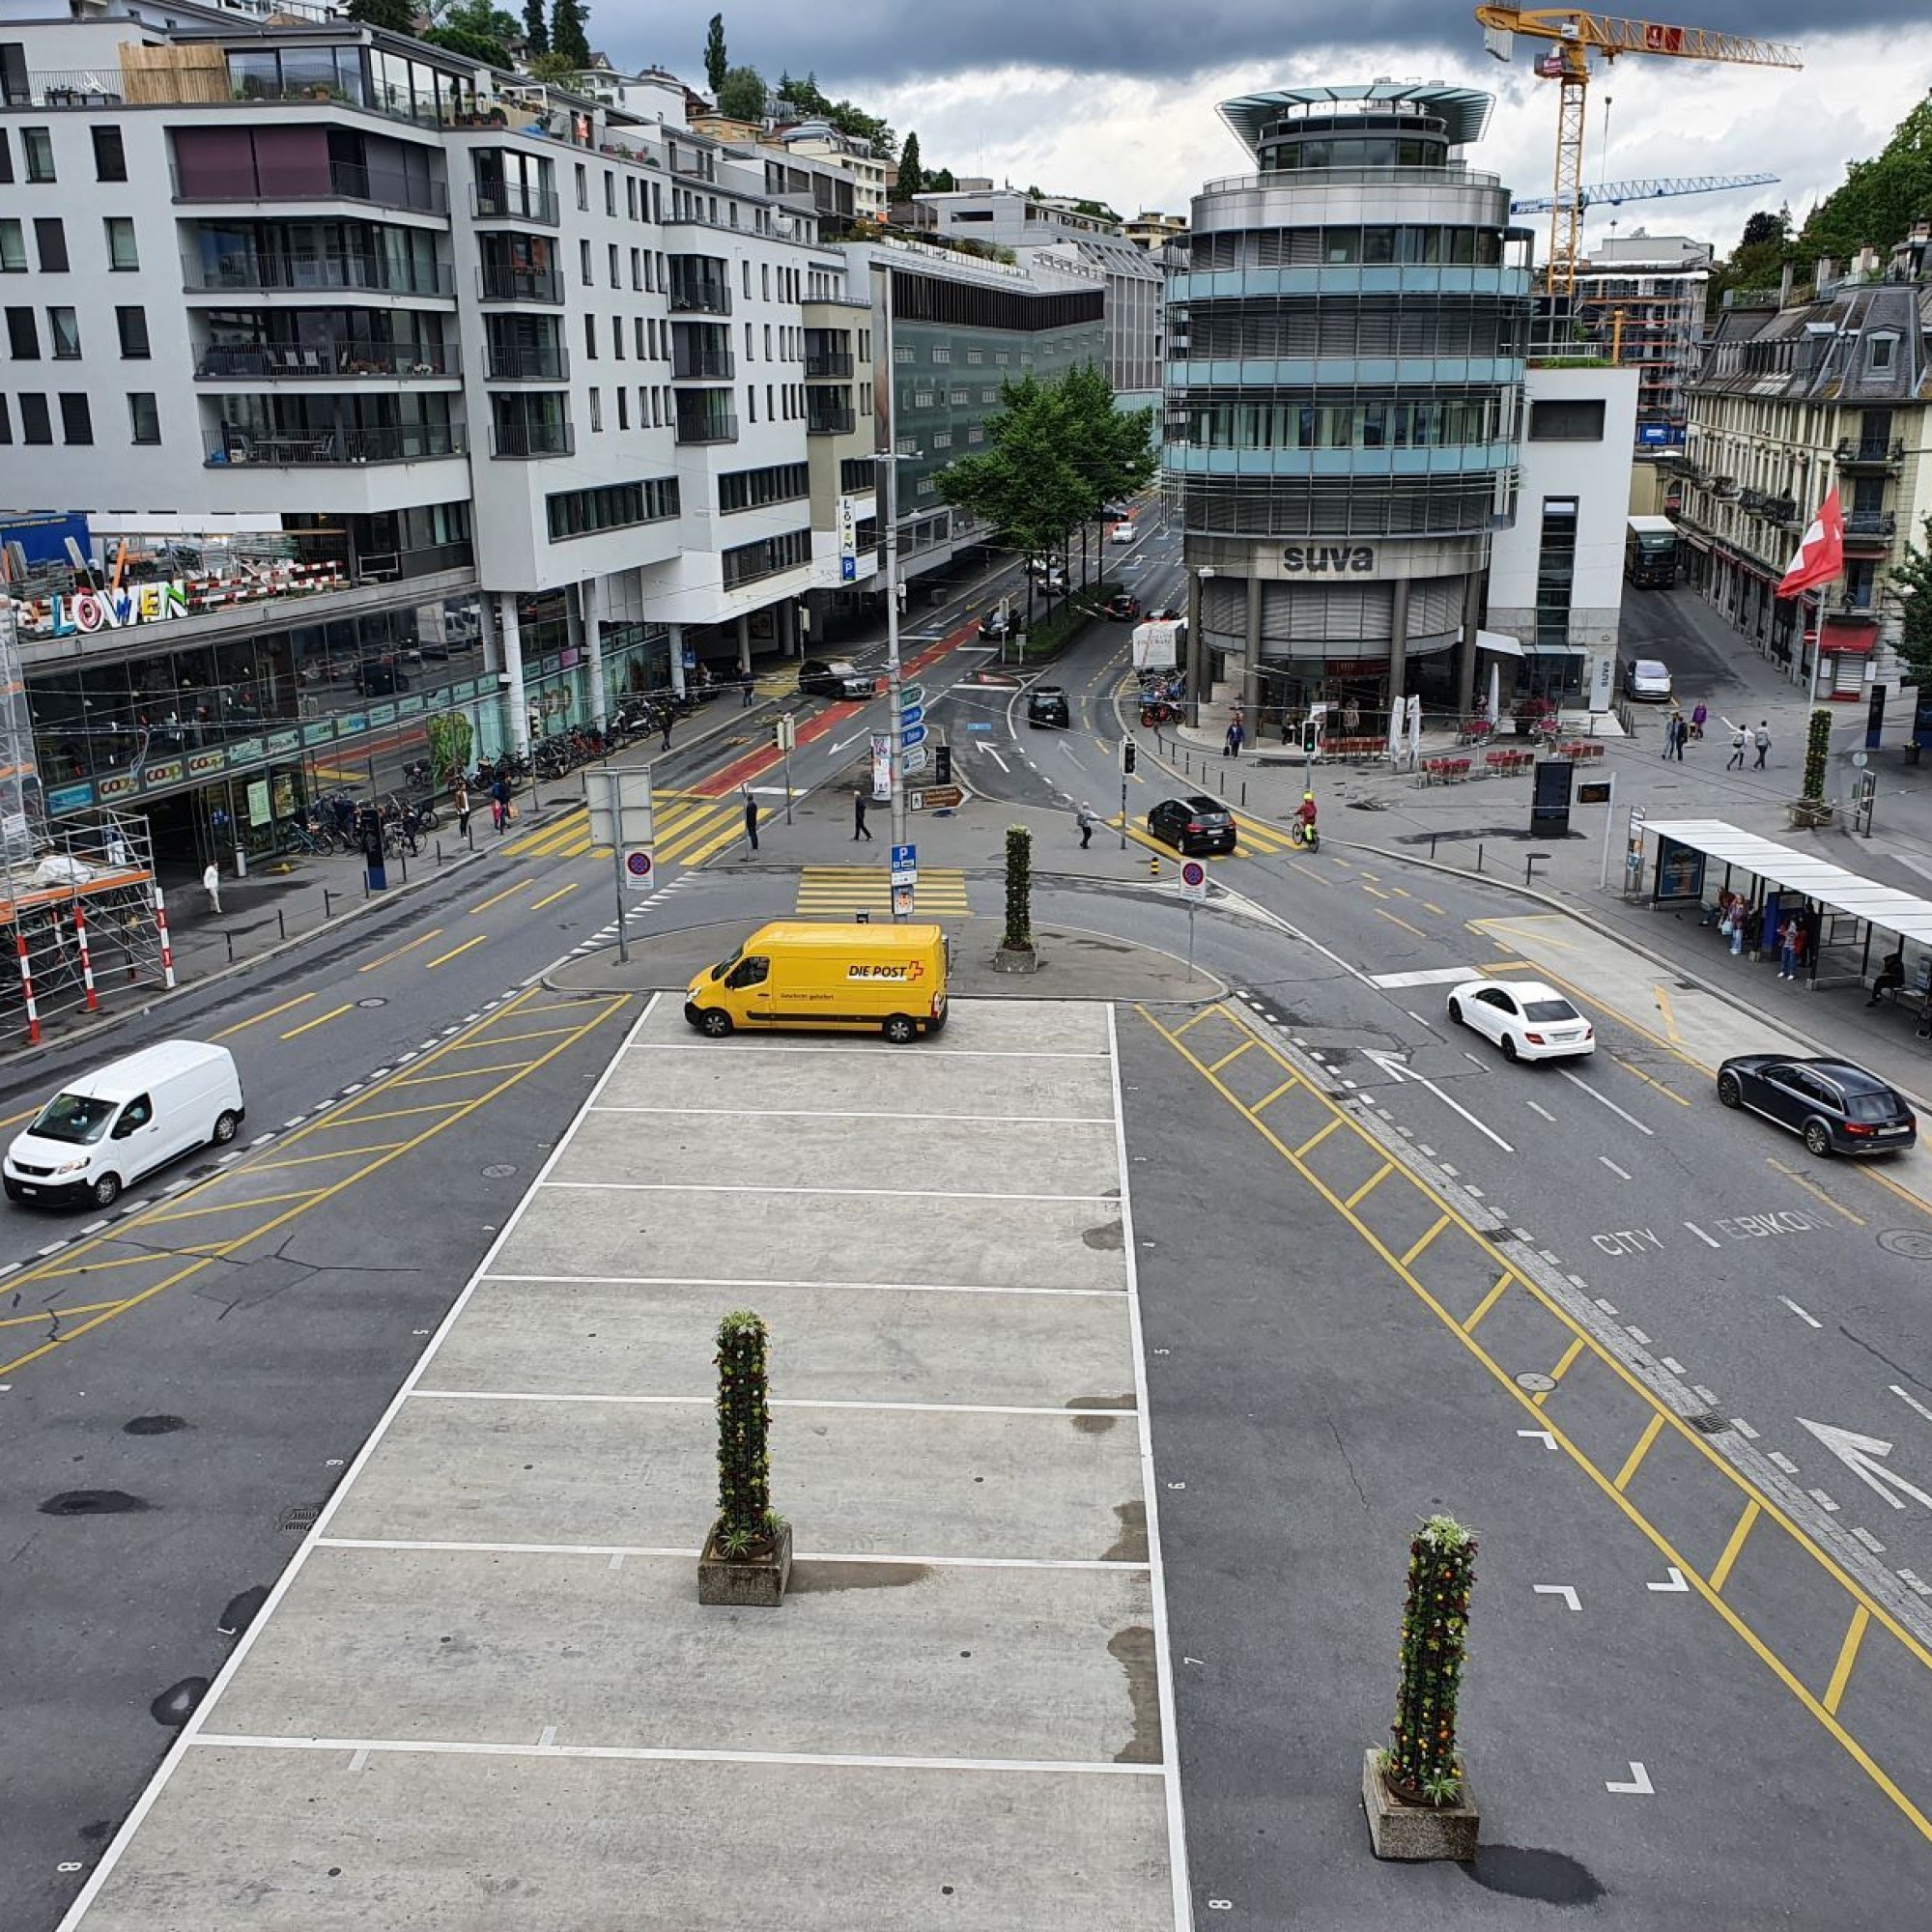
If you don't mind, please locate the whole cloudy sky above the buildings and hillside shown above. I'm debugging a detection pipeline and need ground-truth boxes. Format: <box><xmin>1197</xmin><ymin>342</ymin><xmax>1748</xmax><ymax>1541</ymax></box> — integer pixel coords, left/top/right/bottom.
<box><xmin>614</xmin><ymin>0</ymin><xmax>1932</xmax><ymax>249</ymax></box>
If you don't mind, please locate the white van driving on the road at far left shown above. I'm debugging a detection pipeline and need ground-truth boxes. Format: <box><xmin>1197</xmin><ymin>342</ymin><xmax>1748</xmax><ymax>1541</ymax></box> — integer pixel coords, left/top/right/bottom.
<box><xmin>0</xmin><ymin>1039</ymin><xmax>247</xmax><ymax>1208</ymax></box>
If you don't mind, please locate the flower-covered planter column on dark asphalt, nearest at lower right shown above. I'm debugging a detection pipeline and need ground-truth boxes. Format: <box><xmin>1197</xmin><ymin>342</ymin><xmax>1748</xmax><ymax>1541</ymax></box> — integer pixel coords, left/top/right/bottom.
<box><xmin>1362</xmin><ymin>1517</ymin><xmax>1480</xmax><ymax>1859</ymax></box>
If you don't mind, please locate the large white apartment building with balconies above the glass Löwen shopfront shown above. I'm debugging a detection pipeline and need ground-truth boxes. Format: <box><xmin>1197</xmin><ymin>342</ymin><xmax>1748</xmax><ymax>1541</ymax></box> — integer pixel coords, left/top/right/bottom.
<box><xmin>0</xmin><ymin>0</ymin><xmax>875</xmax><ymax>850</ymax></box>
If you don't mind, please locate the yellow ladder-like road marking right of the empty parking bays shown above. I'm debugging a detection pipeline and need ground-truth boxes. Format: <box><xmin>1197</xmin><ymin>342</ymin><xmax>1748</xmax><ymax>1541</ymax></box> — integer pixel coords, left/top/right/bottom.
<box><xmin>1136</xmin><ymin>1007</ymin><xmax>1932</xmax><ymax>1841</ymax></box>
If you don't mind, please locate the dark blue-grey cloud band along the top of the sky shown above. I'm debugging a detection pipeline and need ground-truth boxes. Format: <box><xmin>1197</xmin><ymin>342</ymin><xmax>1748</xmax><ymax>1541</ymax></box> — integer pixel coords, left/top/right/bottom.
<box><xmin>638</xmin><ymin>0</ymin><xmax>1932</xmax><ymax>93</ymax></box>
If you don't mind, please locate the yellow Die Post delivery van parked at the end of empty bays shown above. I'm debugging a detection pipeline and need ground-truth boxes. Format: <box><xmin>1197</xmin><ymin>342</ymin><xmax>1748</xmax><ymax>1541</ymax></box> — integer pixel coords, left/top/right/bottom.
<box><xmin>684</xmin><ymin>922</ymin><xmax>949</xmax><ymax>1045</ymax></box>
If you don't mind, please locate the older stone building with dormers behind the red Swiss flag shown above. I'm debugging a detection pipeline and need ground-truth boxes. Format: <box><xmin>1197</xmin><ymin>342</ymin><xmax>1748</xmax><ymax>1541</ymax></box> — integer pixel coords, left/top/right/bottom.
<box><xmin>1679</xmin><ymin>222</ymin><xmax>1932</xmax><ymax>697</ymax></box>
